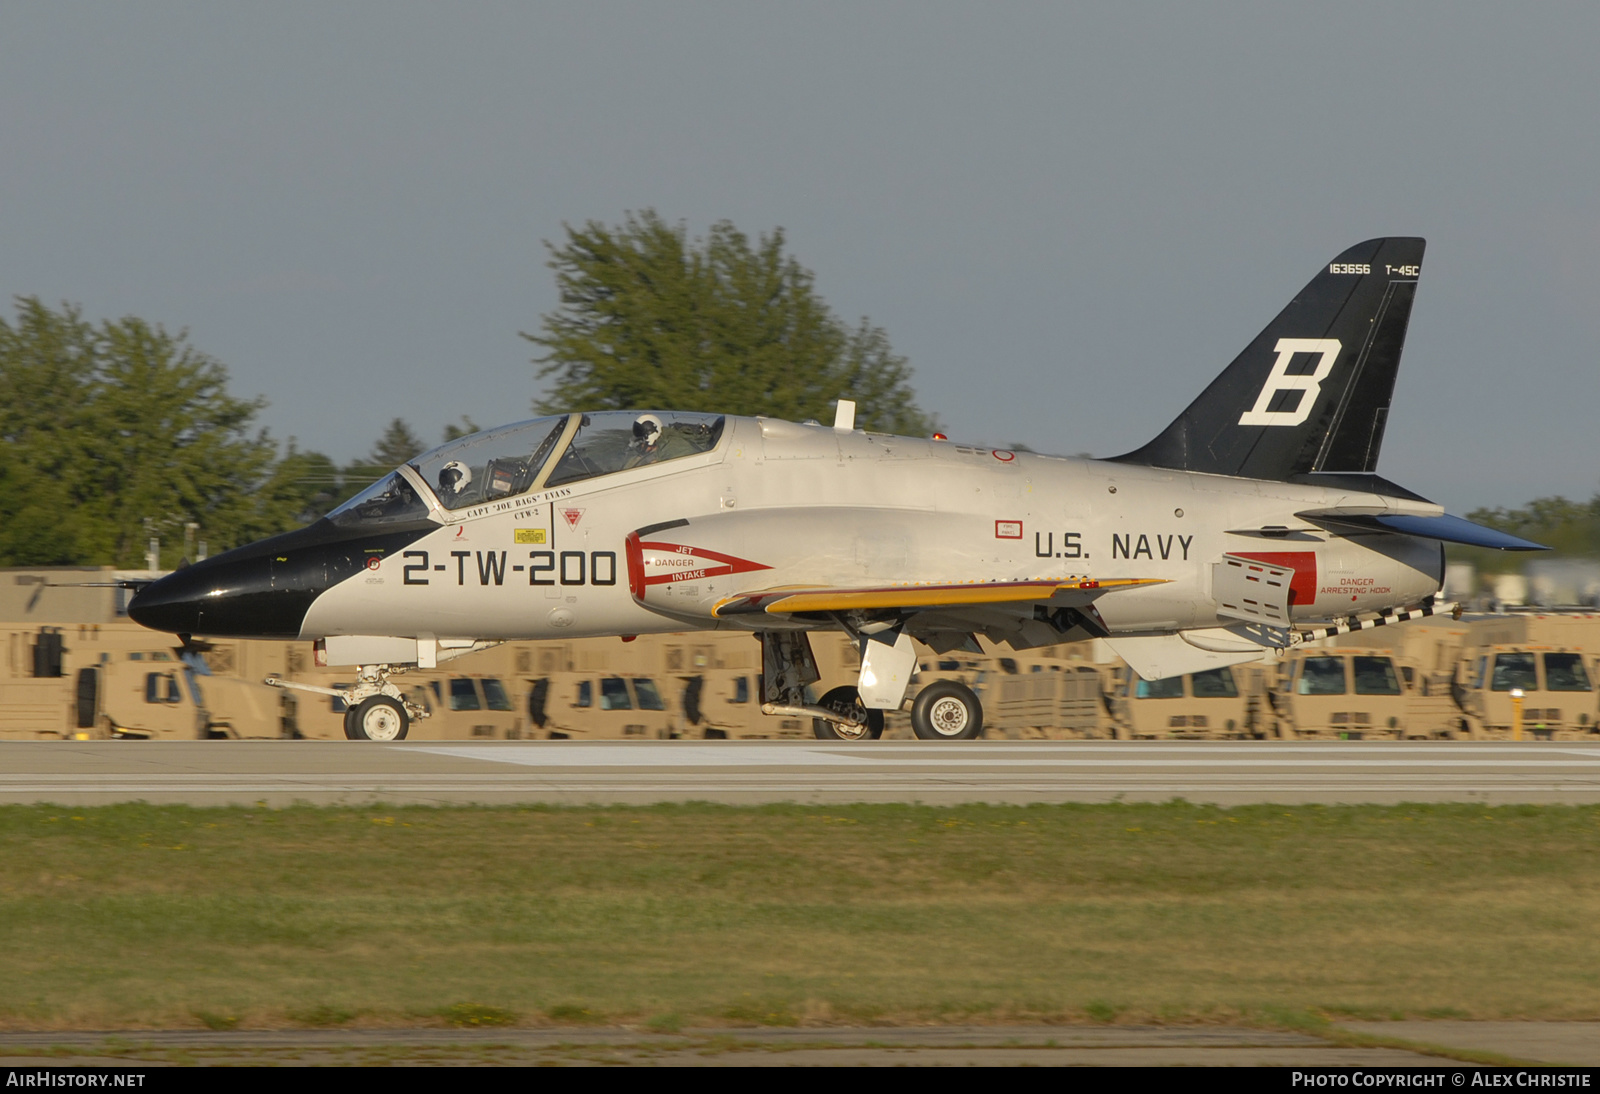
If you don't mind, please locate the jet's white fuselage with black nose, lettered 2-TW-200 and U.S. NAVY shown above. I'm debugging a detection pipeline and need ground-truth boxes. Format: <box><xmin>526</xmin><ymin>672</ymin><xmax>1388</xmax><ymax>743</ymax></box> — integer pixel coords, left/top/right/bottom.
<box><xmin>130</xmin><ymin>413</ymin><xmax>1443</xmax><ymax>640</ymax></box>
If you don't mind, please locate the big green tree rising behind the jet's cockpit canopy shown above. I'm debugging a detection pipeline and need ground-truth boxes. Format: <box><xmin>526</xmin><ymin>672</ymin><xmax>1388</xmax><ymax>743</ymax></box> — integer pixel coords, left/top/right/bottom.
<box><xmin>523</xmin><ymin>210</ymin><xmax>933</xmax><ymax>435</ymax></box>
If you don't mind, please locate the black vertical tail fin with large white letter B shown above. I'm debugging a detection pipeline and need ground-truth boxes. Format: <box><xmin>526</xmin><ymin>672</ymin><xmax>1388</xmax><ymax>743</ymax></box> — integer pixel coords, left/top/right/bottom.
<box><xmin>1115</xmin><ymin>237</ymin><xmax>1424</xmax><ymax>481</ymax></box>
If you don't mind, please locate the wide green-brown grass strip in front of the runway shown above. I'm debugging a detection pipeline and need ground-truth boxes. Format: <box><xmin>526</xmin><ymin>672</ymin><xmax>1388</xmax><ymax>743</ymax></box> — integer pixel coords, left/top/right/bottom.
<box><xmin>0</xmin><ymin>803</ymin><xmax>1600</xmax><ymax>1030</ymax></box>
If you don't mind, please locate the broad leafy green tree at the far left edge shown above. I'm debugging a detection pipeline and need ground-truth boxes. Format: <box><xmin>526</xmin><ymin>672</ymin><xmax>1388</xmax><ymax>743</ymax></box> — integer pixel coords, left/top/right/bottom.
<box><xmin>0</xmin><ymin>297</ymin><xmax>293</xmax><ymax>566</ymax></box>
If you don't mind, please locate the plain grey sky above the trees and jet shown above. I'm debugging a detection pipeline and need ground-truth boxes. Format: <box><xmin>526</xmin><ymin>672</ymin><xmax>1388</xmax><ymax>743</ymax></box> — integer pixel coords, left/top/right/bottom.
<box><xmin>0</xmin><ymin>0</ymin><xmax>1600</xmax><ymax>512</ymax></box>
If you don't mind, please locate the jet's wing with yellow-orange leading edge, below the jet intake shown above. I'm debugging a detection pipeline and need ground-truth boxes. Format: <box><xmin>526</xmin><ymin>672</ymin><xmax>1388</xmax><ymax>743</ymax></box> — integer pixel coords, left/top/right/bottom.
<box><xmin>712</xmin><ymin>577</ymin><xmax>1162</xmax><ymax>619</ymax></box>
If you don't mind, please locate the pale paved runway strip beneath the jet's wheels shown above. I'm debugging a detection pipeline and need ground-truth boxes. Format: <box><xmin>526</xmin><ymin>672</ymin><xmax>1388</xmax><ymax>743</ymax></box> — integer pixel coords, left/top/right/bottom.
<box><xmin>0</xmin><ymin>741</ymin><xmax>1600</xmax><ymax>806</ymax></box>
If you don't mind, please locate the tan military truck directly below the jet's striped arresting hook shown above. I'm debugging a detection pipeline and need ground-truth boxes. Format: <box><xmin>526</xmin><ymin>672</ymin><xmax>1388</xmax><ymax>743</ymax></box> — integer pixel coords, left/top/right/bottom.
<box><xmin>1264</xmin><ymin>646</ymin><xmax>1459</xmax><ymax>741</ymax></box>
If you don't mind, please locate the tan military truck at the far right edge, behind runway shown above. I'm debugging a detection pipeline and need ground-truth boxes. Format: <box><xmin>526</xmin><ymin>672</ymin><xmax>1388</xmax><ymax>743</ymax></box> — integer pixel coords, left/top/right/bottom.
<box><xmin>1454</xmin><ymin>645</ymin><xmax>1600</xmax><ymax>741</ymax></box>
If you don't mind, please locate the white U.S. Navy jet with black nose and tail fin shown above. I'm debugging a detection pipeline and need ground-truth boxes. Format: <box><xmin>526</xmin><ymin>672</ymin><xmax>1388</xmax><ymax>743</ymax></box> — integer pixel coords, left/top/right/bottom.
<box><xmin>128</xmin><ymin>238</ymin><xmax>1539</xmax><ymax>741</ymax></box>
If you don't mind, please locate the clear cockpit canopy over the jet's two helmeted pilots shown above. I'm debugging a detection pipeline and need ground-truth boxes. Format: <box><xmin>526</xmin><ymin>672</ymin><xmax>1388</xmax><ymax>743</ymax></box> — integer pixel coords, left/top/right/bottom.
<box><xmin>328</xmin><ymin>411</ymin><xmax>725</xmax><ymax>525</ymax></box>
